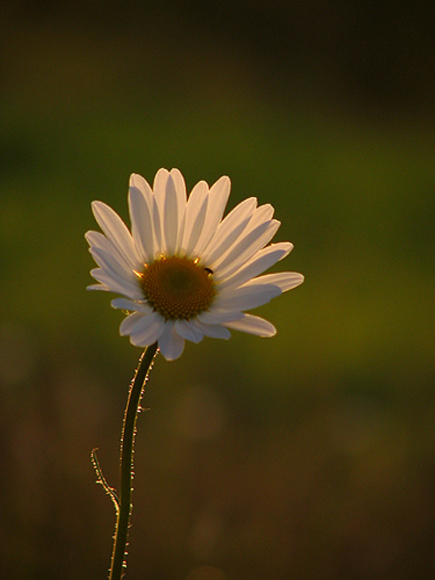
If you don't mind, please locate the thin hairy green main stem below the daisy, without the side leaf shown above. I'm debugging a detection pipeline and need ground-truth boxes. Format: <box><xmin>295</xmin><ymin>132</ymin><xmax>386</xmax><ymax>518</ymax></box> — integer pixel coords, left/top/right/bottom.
<box><xmin>109</xmin><ymin>343</ymin><xmax>157</xmax><ymax>580</ymax></box>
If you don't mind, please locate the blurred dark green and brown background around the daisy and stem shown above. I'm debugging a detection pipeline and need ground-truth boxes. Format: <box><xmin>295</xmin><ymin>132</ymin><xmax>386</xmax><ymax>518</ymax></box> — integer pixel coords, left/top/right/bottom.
<box><xmin>0</xmin><ymin>0</ymin><xmax>435</xmax><ymax>580</ymax></box>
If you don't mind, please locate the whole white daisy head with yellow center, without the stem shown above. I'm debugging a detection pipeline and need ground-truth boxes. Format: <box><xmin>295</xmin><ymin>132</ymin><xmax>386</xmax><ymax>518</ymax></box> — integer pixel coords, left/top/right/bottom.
<box><xmin>86</xmin><ymin>169</ymin><xmax>304</xmax><ymax>360</ymax></box>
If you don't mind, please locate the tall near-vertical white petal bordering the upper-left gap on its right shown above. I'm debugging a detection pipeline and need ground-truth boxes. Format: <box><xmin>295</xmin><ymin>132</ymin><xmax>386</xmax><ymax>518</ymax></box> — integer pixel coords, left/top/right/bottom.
<box><xmin>129</xmin><ymin>179</ymin><xmax>154</xmax><ymax>263</ymax></box>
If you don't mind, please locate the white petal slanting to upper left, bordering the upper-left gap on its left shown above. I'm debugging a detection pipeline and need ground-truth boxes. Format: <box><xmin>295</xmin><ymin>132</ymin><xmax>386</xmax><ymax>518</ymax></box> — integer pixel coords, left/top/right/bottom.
<box><xmin>91</xmin><ymin>201</ymin><xmax>138</xmax><ymax>267</ymax></box>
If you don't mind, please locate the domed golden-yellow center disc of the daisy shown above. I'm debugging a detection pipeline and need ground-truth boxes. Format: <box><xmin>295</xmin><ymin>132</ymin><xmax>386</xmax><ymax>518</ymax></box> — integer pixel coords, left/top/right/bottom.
<box><xmin>138</xmin><ymin>256</ymin><xmax>216</xmax><ymax>320</ymax></box>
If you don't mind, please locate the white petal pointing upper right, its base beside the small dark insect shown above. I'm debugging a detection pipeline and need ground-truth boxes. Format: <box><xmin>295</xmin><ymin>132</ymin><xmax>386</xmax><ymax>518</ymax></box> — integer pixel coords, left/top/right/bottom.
<box><xmin>214</xmin><ymin>220</ymin><xmax>281</xmax><ymax>281</ymax></box>
